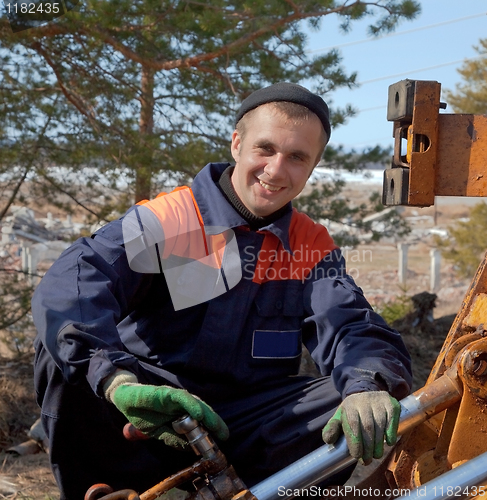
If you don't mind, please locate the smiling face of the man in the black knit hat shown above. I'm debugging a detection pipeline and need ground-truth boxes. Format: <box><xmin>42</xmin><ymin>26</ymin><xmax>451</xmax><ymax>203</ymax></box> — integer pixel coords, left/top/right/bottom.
<box><xmin>231</xmin><ymin>104</ymin><xmax>323</xmax><ymax>217</ymax></box>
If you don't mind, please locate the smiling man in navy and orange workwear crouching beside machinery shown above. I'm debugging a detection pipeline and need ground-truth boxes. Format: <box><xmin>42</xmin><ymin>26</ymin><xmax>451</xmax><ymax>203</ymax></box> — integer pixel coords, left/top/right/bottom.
<box><xmin>33</xmin><ymin>83</ymin><xmax>411</xmax><ymax>500</ymax></box>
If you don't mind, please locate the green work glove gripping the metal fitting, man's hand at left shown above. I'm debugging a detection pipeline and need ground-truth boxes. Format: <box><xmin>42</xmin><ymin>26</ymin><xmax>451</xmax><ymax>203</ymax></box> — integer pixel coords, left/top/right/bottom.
<box><xmin>111</xmin><ymin>384</ymin><xmax>228</xmax><ymax>448</ymax></box>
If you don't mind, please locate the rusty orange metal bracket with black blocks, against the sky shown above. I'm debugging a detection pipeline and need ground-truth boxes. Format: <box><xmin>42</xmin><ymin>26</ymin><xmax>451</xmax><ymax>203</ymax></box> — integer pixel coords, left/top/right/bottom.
<box><xmin>382</xmin><ymin>80</ymin><xmax>487</xmax><ymax>207</ymax></box>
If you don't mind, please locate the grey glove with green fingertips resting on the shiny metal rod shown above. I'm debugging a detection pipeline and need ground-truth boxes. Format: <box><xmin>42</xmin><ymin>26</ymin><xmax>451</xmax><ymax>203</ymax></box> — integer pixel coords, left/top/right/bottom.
<box><xmin>322</xmin><ymin>391</ymin><xmax>401</xmax><ymax>465</ymax></box>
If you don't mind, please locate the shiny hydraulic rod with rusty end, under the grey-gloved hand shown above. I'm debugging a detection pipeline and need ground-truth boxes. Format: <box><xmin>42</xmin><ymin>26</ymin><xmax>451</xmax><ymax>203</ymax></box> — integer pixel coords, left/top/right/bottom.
<box><xmin>250</xmin><ymin>368</ymin><xmax>462</xmax><ymax>500</ymax></box>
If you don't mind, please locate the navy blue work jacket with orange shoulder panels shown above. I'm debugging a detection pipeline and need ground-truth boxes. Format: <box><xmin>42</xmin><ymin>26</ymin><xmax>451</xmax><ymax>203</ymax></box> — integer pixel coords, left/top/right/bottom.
<box><xmin>32</xmin><ymin>164</ymin><xmax>411</xmax><ymax>403</ymax></box>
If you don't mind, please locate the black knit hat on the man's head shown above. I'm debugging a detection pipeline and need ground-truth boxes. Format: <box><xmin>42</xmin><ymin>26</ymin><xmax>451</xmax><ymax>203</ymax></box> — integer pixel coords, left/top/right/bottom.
<box><xmin>235</xmin><ymin>82</ymin><xmax>331</xmax><ymax>140</ymax></box>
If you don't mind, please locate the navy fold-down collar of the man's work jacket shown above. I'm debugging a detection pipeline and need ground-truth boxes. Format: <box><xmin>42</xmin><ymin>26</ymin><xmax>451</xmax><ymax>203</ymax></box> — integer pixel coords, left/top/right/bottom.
<box><xmin>191</xmin><ymin>163</ymin><xmax>293</xmax><ymax>253</ymax></box>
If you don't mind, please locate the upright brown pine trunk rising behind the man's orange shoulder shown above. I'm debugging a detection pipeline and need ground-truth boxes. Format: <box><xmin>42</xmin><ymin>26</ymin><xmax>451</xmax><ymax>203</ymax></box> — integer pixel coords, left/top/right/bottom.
<box><xmin>135</xmin><ymin>66</ymin><xmax>154</xmax><ymax>203</ymax></box>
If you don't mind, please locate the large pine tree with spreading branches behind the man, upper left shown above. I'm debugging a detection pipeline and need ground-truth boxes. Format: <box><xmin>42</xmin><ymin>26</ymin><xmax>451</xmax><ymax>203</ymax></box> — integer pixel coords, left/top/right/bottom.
<box><xmin>0</xmin><ymin>0</ymin><xmax>419</xmax><ymax>213</ymax></box>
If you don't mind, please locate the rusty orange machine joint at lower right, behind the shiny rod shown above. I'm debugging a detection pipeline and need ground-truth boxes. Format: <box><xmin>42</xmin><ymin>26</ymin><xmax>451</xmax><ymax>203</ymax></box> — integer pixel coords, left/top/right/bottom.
<box><xmin>387</xmin><ymin>336</ymin><xmax>487</xmax><ymax>488</ymax></box>
